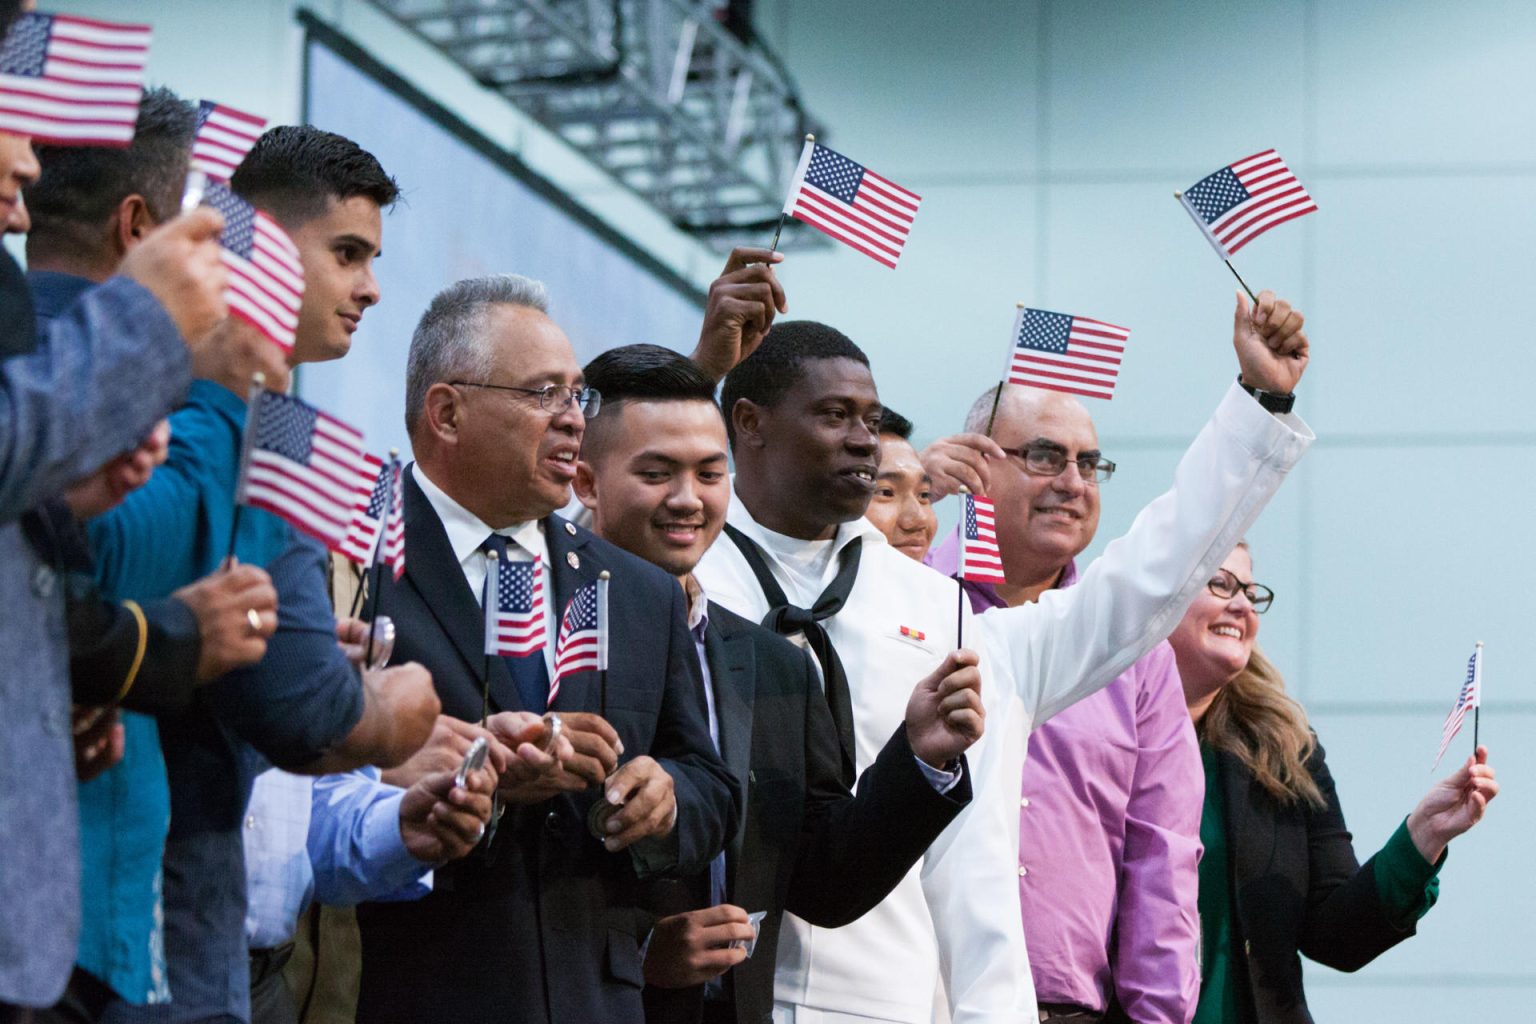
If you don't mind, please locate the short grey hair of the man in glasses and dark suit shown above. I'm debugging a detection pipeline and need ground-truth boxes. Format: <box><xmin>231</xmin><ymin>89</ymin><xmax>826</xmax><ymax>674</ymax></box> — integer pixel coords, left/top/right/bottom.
<box><xmin>406</xmin><ymin>273</ymin><xmax>550</xmax><ymax>436</ymax></box>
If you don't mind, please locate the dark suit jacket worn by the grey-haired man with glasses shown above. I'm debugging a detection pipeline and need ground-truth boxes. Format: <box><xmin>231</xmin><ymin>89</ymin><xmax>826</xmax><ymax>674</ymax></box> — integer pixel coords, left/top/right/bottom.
<box><xmin>358</xmin><ymin>477</ymin><xmax>739</xmax><ymax>1024</ymax></box>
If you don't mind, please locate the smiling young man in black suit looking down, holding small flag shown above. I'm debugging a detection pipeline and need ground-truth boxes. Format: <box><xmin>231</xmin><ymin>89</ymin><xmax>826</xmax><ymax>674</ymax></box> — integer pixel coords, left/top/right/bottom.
<box><xmin>576</xmin><ymin>345</ymin><xmax>983</xmax><ymax>1024</ymax></box>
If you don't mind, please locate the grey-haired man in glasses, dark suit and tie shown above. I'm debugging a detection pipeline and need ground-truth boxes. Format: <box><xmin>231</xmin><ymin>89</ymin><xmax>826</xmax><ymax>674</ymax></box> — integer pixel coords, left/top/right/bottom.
<box><xmin>358</xmin><ymin>275</ymin><xmax>740</xmax><ymax>1024</ymax></box>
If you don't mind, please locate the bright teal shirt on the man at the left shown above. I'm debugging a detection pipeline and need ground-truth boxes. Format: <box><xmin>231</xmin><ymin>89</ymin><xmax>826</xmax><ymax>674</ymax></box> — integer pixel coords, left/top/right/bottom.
<box><xmin>77</xmin><ymin>381</ymin><xmax>289</xmax><ymax>1004</ymax></box>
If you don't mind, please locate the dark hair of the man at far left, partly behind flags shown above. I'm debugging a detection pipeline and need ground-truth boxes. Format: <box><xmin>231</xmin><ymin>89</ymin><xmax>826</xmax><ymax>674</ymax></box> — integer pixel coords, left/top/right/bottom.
<box><xmin>26</xmin><ymin>88</ymin><xmax>197</xmax><ymax>253</ymax></box>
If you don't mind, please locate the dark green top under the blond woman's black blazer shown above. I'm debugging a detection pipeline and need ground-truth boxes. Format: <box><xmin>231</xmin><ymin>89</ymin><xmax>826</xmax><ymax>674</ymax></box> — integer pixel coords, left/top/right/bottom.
<box><xmin>1193</xmin><ymin>745</ymin><xmax>1445</xmax><ymax>1024</ymax></box>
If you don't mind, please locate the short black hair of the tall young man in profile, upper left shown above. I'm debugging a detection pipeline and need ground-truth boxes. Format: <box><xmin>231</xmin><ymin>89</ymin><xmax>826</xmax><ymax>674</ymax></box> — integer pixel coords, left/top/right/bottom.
<box><xmin>229</xmin><ymin>124</ymin><xmax>399</xmax><ymax>230</ymax></box>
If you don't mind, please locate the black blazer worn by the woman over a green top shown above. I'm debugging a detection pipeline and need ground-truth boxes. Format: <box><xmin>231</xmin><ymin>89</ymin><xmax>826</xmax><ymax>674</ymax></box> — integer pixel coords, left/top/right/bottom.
<box><xmin>1217</xmin><ymin>745</ymin><xmax>1415</xmax><ymax>1024</ymax></box>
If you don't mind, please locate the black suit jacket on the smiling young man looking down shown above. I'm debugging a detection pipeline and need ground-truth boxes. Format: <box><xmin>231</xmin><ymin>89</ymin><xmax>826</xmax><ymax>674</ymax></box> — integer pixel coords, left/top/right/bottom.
<box><xmin>645</xmin><ymin>603</ymin><xmax>971</xmax><ymax>1024</ymax></box>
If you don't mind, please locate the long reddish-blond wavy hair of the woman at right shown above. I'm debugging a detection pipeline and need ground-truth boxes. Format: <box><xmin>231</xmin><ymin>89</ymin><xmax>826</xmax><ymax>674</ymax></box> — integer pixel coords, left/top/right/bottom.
<box><xmin>1195</xmin><ymin>542</ymin><xmax>1324</xmax><ymax>808</ymax></box>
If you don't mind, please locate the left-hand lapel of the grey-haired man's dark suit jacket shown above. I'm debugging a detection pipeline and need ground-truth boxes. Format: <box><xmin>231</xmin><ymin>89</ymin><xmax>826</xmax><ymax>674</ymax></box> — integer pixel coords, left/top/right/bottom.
<box><xmin>406</xmin><ymin>473</ymin><xmax>522</xmax><ymax>709</ymax></box>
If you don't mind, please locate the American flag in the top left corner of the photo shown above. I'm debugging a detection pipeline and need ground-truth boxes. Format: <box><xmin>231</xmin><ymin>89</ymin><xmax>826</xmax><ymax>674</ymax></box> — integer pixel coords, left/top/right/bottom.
<box><xmin>0</xmin><ymin>14</ymin><xmax>149</xmax><ymax>146</ymax></box>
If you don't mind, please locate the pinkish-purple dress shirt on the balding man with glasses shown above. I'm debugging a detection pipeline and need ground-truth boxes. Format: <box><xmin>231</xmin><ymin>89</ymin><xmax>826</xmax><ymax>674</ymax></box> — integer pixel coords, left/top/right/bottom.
<box><xmin>926</xmin><ymin>533</ymin><xmax>1206</xmax><ymax>1024</ymax></box>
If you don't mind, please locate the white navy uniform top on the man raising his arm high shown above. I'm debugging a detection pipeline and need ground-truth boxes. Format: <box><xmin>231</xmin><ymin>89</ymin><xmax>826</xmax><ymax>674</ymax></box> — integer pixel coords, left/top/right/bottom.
<box><xmin>697</xmin><ymin>385</ymin><xmax>1313</xmax><ymax>1024</ymax></box>
